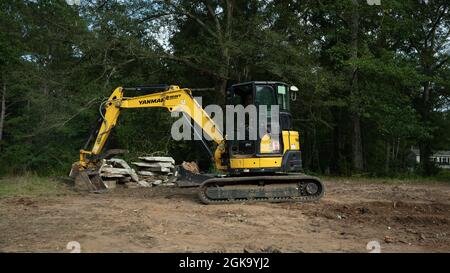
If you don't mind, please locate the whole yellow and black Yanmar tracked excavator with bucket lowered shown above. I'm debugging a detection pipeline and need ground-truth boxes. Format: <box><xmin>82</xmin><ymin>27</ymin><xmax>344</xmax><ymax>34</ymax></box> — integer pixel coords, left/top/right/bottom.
<box><xmin>71</xmin><ymin>81</ymin><xmax>324</xmax><ymax>204</ymax></box>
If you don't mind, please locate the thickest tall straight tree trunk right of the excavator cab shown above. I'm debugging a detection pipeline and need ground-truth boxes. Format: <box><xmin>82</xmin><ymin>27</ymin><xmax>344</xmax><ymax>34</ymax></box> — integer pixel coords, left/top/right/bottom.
<box><xmin>350</xmin><ymin>0</ymin><xmax>364</xmax><ymax>171</ymax></box>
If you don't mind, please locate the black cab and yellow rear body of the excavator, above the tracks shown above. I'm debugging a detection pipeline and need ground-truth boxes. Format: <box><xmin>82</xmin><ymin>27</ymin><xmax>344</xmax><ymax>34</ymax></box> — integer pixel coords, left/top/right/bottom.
<box><xmin>227</xmin><ymin>81</ymin><xmax>301</xmax><ymax>174</ymax></box>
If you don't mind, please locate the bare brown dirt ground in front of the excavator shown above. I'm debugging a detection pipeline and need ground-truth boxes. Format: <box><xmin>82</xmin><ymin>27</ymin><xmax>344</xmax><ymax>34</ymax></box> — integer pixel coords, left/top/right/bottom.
<box><xmin>0</xmin><ymin>177</ymin><xmax>450</xmax><ymax>252</ymax></box>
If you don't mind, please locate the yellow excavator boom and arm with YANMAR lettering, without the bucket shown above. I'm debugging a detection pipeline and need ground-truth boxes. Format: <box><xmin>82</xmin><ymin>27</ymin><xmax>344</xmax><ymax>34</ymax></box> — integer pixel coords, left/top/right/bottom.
<box><xmin>79</xmin><ymin>85</ymin><xmax>226</xmax><ymax>170</ymax></box>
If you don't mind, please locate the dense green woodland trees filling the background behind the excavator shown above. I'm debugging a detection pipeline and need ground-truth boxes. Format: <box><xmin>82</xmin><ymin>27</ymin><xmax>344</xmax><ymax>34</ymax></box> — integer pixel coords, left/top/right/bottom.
<box><xmin>0</xmin><ymin>0</ymin><xmax>450</xmax><ymax>180</ymax></box>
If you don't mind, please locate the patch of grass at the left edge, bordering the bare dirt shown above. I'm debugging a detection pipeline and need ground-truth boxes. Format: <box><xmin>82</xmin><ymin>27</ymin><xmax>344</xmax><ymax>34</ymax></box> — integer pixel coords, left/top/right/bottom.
<box><xmin>0</xmin><ymin>174</ymin><xmax>70</xmax><ymax>198</ymax></box>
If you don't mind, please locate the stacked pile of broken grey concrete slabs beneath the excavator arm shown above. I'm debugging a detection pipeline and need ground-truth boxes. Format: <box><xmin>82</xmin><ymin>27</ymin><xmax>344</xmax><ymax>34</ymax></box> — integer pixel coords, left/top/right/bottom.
<box><xmin>99</xmin><ymin>156</ymin><xmax>177</xmax><ymax>189</ymax></box>
